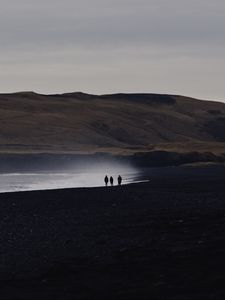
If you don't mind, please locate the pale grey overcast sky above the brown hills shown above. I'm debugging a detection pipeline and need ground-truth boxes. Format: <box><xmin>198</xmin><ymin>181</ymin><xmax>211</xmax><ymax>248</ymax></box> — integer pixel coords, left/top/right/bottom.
<box><xmin>0</xmin><ymin>0</ymin><xmax>225</xmax><ymax>101</ymax></box>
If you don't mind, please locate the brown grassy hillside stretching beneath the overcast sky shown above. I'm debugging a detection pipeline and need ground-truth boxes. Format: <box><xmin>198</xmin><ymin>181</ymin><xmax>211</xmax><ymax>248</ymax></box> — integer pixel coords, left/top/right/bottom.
<box><xmin>0</xmin><ymin>92</ymin><xmax>225</xmax><ymax>153</ymax></box>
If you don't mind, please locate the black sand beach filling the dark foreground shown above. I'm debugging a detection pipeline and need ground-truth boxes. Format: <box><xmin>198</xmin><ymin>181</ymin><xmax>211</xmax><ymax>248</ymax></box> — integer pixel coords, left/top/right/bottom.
<box><xmin>0</xmin><ymin>170</ymin><xmax>225</xmax><ymax>300</ymax></box>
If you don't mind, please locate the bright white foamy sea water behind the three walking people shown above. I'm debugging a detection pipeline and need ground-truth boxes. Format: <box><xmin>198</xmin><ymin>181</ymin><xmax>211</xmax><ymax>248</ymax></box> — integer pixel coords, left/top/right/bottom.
<box><xmin>0</xmin><ymin>170</ymin><xmax>144</xmax><ymax>193</ymax></box>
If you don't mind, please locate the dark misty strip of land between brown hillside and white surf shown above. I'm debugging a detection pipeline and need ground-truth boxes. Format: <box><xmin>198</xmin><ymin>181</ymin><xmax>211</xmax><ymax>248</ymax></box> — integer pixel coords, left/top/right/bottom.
<box><xmin>0</xmin><ymin>150</ymin><xmax>225</xmax><ymax>173</ymax></box>
